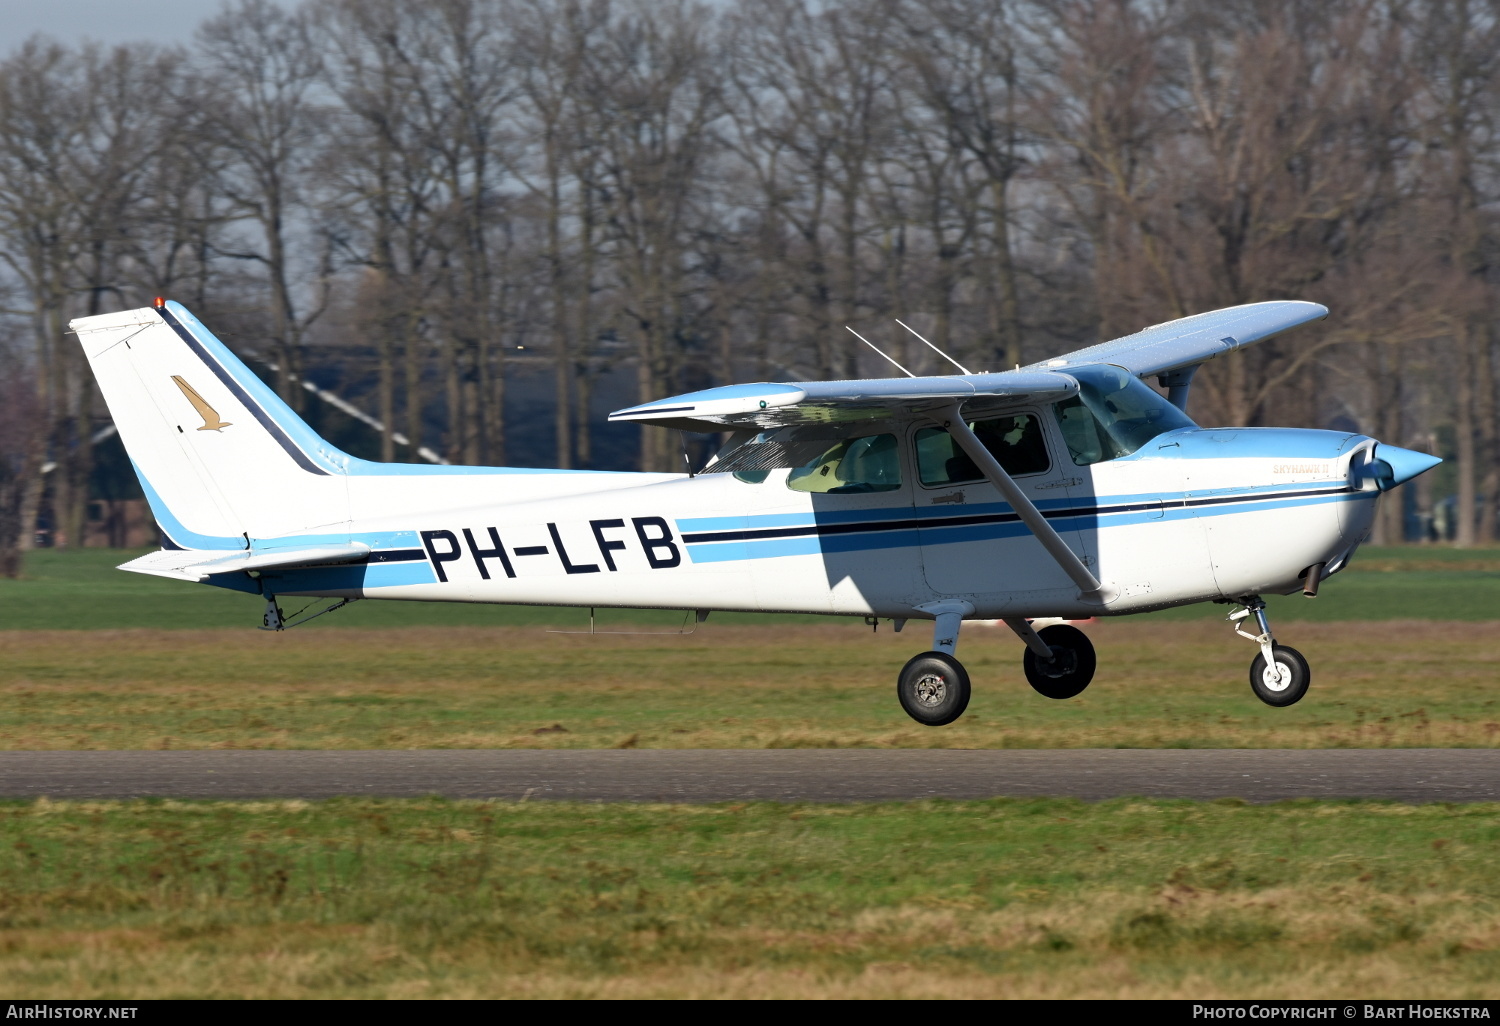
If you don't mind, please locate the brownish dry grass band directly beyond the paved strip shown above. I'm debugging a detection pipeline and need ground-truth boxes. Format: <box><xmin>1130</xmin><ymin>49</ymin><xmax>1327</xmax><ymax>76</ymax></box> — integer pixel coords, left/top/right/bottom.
<box><xmin>0</xmin><ymin>620</ymin><xmax>1500</xmax><ymax>750</ymax></box>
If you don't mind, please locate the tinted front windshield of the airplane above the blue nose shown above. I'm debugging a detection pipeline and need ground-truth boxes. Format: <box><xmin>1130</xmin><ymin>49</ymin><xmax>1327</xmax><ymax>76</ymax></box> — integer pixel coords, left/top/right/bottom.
<box><xmin>1056</xmin><ymin>366</ymin><xmax>1194</xmax><ymax>467</ymax></box>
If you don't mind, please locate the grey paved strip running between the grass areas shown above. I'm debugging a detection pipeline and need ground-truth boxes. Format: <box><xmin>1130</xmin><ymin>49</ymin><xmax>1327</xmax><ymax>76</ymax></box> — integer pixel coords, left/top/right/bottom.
<box><xmin>0</xmin><ymin>749</ymin><xmax>1500</xmax><ymax>803</ymax></box>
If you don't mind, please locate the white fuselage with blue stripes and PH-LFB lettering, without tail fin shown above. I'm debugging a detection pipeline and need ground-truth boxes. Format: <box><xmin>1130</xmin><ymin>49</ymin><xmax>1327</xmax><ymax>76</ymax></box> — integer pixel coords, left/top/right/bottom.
<box><xmin>240</xmin><ymin>411</ymin><xmax>1379</xmax><ymax>618</ymax></box>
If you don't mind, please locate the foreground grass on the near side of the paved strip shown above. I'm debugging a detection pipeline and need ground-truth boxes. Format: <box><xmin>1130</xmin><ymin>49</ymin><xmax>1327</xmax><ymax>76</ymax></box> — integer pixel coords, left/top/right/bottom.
<box><xmin>0</xmin><ymin>800</ymin><xmax>1500</xmax><ymax>999</ymax></box>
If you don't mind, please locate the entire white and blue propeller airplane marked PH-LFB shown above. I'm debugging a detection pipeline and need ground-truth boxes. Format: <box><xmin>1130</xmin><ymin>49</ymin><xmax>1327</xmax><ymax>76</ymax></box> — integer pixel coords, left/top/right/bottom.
<box><xmin>72</xmin><ymin>300</ymin><xmax>1440</xmax><ymax>726</ymax></box>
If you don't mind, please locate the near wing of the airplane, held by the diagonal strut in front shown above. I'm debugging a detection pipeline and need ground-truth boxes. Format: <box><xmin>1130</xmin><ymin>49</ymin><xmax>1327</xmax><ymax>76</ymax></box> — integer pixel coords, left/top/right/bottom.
<box><xmin>609</xmin><ymin>371</ymin><xmax>1079</xmax><ymax>432</ymax></box>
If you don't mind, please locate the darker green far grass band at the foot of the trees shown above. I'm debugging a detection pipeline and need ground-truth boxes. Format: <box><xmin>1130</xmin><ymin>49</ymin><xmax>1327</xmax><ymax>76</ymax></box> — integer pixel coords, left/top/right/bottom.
<box><xmin>0</xmin><ymin>548</ymin><xmax>1500</xmax><ymax>630</ymax></box>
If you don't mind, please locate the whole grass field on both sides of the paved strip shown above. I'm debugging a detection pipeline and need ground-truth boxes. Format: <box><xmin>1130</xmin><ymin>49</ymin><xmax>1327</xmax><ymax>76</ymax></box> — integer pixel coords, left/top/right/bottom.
<box><xmin>0</xmin><ymin>549</ymin><xmax>1500</xmax><ymax>999</ymax></box>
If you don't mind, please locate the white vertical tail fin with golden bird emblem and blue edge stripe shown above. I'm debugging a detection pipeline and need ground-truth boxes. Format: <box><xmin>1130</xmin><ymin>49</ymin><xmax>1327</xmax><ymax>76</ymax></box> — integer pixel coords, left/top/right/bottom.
<box><xmin>71</xmin><ymin>303</ymin><xmax>354</xmax><ymax>551</ymax></box>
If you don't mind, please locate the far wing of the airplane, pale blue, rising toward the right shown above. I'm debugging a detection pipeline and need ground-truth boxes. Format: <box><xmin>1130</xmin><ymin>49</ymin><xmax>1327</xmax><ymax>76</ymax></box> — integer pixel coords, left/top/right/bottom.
<box><xmin>1026</xmin><ymin>300</ymin><xmax>1328</xmax><ymax>378</ymax></box>
